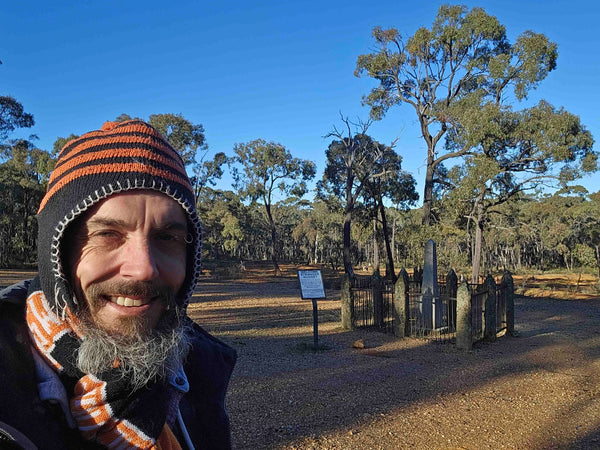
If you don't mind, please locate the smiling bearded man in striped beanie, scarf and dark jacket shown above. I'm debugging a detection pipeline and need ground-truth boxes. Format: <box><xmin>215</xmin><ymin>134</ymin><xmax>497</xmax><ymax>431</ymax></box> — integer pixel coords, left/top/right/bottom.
<box><xmin>0</xmin><ymin>120</ymin><xmax>236</xmax><ymax>449</ymax></box>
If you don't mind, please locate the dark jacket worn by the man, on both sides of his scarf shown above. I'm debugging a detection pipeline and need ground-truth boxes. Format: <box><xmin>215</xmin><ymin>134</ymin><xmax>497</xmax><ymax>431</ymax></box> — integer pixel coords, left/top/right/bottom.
<box><xmin>0</xmin><ymin>282</ymin><xmax>236</xmax><ymax>449</ymax></box>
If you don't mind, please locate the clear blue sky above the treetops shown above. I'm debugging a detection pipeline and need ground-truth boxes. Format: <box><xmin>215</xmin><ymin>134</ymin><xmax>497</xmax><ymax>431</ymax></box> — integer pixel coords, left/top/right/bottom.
<box><xmin>0</xmin><ymin>0</ymin><xmax>600</xmax><ymax>200</ymax></box>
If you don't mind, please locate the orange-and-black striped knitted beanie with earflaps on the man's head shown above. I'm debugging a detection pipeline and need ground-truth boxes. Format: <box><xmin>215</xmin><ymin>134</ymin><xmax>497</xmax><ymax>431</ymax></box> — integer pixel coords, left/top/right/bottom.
<box><xmin>38</xmin><ymin>120</ymin><xmax>201</xmax><ymax>315</ymax></box>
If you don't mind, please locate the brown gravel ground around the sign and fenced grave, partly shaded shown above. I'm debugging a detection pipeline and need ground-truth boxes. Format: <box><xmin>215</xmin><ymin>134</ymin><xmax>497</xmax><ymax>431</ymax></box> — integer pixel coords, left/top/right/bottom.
<box><xmin>190</xmin><ymin>280</ymin><xmax>600</xmax><ymax>450</ymax></box>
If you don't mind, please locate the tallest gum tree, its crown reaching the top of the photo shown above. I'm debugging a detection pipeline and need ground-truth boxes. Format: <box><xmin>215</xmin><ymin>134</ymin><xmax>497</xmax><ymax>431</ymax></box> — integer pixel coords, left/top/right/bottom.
<box><xmin>355</xmin><ymin>5</ymin><xmax>557</xmax><ymax>225</ymax></box>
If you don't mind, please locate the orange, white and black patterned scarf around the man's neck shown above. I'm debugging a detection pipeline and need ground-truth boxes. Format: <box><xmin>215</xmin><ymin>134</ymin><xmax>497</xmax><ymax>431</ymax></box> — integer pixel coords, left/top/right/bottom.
<box><xmin>26</xmin><ymin>290</ymin><xmax>181</xmax><ymax>450</ymax></box>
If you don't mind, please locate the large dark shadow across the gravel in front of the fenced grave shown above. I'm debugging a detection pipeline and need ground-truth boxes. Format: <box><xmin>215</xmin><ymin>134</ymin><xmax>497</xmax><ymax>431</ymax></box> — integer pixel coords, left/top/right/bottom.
<box><xmin>200</xmin><ymin>290</ymin><xmax>600</xmax><ymax>449</ymax></box>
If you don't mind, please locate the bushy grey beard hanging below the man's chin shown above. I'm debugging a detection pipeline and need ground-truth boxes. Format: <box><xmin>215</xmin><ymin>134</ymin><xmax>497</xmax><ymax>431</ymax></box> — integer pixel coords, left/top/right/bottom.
<box><xmin>77</xmin><ymin>308</ymin><xmax>191</xmax><ymax>391</ymax></box>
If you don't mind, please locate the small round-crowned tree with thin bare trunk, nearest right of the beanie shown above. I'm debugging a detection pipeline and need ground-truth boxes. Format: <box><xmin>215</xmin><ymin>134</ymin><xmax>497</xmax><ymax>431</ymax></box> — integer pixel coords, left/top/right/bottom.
<box><xmin>229</xmin><ymin>139</ymin><xmax>316</xmax><ymax>276</ymax></box>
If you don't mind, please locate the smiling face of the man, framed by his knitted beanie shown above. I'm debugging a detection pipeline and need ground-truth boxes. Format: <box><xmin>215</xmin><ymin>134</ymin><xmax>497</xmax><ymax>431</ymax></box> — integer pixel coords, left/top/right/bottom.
<box><xmin>67</xmin><ymin>190</ymin><xmax>187</xmax><ymax>336</ymax></box>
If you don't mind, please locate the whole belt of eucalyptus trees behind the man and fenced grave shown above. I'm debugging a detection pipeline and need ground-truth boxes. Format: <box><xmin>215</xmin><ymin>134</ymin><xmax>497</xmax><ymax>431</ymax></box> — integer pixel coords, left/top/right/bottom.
<box><xmin>0</xmin><ymin>5</ymin><xmax>600</xmax><ymax>284</ymax></box>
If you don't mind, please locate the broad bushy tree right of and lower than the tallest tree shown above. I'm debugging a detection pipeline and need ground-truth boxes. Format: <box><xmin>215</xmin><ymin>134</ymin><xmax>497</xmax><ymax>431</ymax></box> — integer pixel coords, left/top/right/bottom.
<box><xmin>448</xmin><ymin>101</ymin><xmax>598</xmax><ymax>280</ymax></box>
